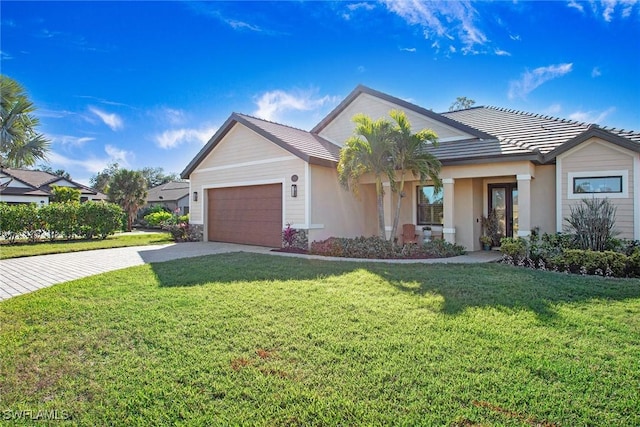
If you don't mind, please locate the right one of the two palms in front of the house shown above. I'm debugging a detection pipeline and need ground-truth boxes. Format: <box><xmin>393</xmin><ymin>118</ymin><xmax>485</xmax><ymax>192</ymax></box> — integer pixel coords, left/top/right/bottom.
<box><xmin>389</xmin><ymin>110</ymin><xmax>442</xmax><ymax>238</ymax></box>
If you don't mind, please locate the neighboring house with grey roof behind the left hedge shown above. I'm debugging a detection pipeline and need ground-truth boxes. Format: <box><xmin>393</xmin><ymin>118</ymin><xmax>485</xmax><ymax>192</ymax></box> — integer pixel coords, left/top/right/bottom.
<box><xmin>0</xmin><ymin>168</ymin><xmax>107</xmax><ymax>205</ymax></box>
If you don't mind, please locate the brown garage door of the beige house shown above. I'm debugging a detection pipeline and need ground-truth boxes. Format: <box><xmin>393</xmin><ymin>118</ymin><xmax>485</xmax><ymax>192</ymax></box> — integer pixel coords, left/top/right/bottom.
<box><xmin>208</xmin><ymin>184</ymin><xmax>282</xmax><ymax>248</ymax></box>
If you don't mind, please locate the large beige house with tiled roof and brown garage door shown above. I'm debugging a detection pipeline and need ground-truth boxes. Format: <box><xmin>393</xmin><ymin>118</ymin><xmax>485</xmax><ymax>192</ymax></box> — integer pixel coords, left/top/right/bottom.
<box><xmin>182</xmin><ymin>86</ymin><xmax>640</xmax><ymax>250</ymax></box>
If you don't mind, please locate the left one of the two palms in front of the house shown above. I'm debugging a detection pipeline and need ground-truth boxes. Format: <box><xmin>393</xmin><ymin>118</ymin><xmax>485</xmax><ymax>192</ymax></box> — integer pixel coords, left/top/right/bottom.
<box><xmin>338</xmin><ymin>114</ymin><xmax>393</xmax><ymax>239</ymax></box>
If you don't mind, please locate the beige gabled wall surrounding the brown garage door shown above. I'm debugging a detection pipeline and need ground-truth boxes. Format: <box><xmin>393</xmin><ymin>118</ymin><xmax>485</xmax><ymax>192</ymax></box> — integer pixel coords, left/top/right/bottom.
<box><xmin>189</xmin><ymin>124</ymin><xmax>306</xmax><ymax>236</ymax></box>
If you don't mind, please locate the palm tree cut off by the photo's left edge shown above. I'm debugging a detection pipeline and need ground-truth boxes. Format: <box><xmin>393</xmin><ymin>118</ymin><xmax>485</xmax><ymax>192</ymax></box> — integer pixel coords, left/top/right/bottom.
<box><xmin>0</xmin><ymin>75</ymin><xmax>50</xmax><ymax>168</ymax></box>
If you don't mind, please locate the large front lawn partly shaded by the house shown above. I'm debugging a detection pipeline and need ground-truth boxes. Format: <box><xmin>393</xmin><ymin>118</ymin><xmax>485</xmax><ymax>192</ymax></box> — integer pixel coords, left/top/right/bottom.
<box><xmin>0</xmin><ymin>253</ymin><xmax>640</xmax><ymax>426</ymax></box>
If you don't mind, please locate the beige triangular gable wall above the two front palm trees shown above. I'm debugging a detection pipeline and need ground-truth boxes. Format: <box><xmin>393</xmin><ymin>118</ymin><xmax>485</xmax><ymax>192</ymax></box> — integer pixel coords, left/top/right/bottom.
<box><xmin>320</xmin><ymin>93</ymin><xmax>470</xmax><ymax>146</ymax></box>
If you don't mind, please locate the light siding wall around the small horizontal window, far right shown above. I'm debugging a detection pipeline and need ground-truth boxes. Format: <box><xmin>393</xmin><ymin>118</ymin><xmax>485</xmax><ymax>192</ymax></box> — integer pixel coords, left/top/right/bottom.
<box><xmin>557</xmin><ymin>138</ymin><xmax>639</xmax><ymax>239</ymax></box>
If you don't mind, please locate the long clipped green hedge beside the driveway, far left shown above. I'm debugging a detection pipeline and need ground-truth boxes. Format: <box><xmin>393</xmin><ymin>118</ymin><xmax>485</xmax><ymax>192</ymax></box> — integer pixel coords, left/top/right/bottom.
<box><xmin>0</xmin><ymin>202</ymin><xmax>124</xmax><ymax>243</ymax></box>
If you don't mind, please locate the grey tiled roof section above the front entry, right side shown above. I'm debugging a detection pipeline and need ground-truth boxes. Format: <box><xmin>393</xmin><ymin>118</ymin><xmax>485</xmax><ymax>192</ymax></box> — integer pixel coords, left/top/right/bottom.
<box><xmin>443</xmin><ymin>107</ymin><xmax>640</xmax><ymax>162</ymax></box>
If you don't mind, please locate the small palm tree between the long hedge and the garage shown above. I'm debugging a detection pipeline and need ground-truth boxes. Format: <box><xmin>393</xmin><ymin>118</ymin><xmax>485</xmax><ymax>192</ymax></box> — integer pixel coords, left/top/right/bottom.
<box><xmin>109</xmin><ymin>169</ymin><xmax>147</xmax><ymax>231</ymax></box>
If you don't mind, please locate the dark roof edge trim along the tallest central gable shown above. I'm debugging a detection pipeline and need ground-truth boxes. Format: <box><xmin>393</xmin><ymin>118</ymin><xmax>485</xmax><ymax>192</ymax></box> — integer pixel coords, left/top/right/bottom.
<box><xmin>311</xmin><ymin>85</ymin><xmax>495</xmax><ymax>140</ymax></box>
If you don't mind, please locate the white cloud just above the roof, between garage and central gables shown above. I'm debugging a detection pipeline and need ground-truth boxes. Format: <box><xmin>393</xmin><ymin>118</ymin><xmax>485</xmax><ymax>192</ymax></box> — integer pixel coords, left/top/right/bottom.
<box><xmin>253</xmin><ymin>90</ymin><xmax>335</xmax><ymax>121</ymax></box>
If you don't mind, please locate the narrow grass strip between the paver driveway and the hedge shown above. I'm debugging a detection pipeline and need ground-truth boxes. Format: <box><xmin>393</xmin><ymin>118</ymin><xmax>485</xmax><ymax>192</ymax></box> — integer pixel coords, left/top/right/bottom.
<box><xmin>0</xmin><ymin>232</ymin><xmax>173</xmax><ymax>259</ymax></box>
